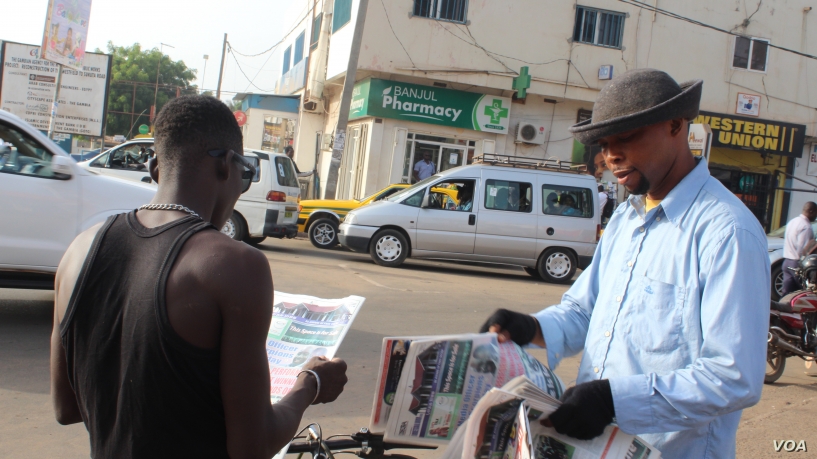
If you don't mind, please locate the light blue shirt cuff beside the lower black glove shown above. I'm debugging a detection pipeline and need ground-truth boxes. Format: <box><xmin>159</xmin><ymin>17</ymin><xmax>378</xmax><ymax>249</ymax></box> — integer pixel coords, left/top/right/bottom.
<box><xmin>609</xmin><ymin>375</ymin><xmax>655</xmax><ymax>435</ymax></box>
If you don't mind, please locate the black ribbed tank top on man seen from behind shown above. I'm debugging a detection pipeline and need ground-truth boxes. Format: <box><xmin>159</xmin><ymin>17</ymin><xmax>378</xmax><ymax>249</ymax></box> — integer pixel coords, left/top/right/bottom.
<box><xmin>60</xmin><ymin>212</ymin><xmax>227</xmax><ymax>458</ymax></box>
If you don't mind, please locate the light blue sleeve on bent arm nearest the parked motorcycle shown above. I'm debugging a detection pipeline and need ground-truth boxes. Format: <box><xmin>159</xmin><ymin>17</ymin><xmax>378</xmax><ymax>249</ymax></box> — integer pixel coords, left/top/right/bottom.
<box><xmin>610</xmin><ymin>229</ymin><xmax>770</xmax><ymax>435</ymax></box>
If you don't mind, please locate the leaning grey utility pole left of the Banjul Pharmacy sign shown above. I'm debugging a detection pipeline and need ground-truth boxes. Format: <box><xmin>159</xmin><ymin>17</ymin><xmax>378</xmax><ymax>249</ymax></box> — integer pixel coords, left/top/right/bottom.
<box><xmin>324</xmin><ymin>0</ymin><xmax>369</xmax><ymax>199</ymax></box>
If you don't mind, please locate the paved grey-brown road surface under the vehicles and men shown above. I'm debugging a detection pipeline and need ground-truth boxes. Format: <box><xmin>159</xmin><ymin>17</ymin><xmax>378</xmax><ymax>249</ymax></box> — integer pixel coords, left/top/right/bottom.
<box><xmin>0</xmin><ymin>239</ymin><xmax>817</xmax><ymax>458</ymax></box>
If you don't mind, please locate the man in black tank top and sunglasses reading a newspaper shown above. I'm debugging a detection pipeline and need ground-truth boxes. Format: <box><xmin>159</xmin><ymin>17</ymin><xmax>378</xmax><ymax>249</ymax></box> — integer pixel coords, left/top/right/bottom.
<box><xmin>51</xmin><ymin>96</ymin><xmax>346</xmax><ymax>459</ymax></box>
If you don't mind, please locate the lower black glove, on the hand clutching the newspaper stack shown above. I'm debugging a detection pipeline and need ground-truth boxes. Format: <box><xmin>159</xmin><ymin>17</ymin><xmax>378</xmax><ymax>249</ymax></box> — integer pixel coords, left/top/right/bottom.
<box><xmin>548</xmin><ymin>379</ymin><xmax>616</xmax><ymax>440</ymax></box>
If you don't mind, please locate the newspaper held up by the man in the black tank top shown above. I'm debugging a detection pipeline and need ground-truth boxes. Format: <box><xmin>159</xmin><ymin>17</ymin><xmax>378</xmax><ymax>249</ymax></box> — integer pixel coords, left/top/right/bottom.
<box><xmin>267</xmin><ymin>291</ymin><xmax>365</xmax><ymax>403</ymax></box>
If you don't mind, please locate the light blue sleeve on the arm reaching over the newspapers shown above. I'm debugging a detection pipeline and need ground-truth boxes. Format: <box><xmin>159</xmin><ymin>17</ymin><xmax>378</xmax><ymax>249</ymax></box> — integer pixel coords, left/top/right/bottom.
<box><xmin>533</xmin><ymin>237</ymin><xmax>604</xmax><ymax>369</ymax></box>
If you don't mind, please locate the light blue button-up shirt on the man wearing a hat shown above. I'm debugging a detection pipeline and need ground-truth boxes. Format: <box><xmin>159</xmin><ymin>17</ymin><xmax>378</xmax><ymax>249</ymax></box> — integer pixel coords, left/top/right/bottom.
<box><xmin>535</xmin><ymin>161</ymin><xmax>770</xmax><ymax>459</ymax></box>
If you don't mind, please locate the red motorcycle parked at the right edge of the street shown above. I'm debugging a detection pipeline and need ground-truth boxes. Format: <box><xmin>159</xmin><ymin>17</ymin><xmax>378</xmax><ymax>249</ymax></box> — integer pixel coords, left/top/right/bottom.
<box><xmin>764</xmin><ymin>254</ymin><xmax>817</xmax><ymax>384</ymax></box>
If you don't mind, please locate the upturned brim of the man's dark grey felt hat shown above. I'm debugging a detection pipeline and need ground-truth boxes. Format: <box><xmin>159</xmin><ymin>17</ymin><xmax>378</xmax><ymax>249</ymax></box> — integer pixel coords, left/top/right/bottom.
<box><xmin>568</xmin><ymin>80</ymin><xmax>704</xmax><ymax>145</ymax></box>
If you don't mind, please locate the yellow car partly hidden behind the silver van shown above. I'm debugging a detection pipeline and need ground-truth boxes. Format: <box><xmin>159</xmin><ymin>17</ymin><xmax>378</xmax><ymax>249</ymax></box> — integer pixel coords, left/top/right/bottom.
<box><xmin>298</xmin><ymin>183</ymin><xmax>457</xmax><ymax>249</ymax></box>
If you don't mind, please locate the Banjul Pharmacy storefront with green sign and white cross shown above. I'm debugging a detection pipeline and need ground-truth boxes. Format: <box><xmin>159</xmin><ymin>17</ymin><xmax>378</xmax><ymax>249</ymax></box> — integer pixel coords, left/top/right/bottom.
<box><xmin>338</xmin><ymin>78</ymin><xmax>511</xmax><ymax>199</ymax></box>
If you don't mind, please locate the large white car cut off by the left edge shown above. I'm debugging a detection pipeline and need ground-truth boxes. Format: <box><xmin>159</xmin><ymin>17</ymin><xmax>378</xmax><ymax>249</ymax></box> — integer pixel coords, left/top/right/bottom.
<box><xmin>0</xmin><ymin>110</ymin><xmax>156</xmax><ymax>289</ymax></box>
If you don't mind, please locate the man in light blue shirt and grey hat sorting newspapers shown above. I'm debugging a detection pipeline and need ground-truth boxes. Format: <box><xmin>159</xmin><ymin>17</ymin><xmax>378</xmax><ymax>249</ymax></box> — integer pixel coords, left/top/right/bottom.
<box><xmin>483</xmin><ymin>69</ymin><xmax>770</xmax><ymax>459</ymax></box>
